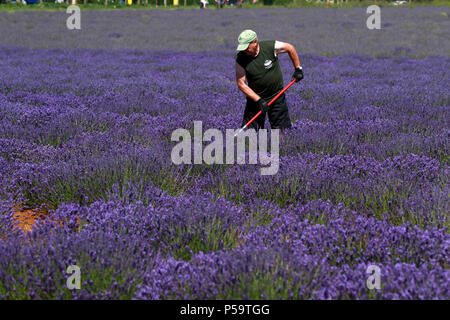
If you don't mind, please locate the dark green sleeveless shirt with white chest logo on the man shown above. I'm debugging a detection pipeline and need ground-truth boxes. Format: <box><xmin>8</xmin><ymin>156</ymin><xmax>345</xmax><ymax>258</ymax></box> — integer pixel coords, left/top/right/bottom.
<box><xmin>235</xmin><ymin>40</ymin><xmax>284</xmax><ymax>102</ymax></box>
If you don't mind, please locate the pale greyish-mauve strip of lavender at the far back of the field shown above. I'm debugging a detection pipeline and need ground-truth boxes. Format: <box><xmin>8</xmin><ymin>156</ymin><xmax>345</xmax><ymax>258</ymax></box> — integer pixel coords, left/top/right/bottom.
<box><xmin>0</xmin><ymin>7</ymin><xmax>450</xmax><ymax>58</ymax></box>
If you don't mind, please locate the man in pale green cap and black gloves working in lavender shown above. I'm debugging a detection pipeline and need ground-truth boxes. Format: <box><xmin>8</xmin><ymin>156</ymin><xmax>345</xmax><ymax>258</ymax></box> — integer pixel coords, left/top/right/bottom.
<box><xmin>236</xmin><ymin>30</ymin><xmax>303</xmax><ymax>137</ymax></box>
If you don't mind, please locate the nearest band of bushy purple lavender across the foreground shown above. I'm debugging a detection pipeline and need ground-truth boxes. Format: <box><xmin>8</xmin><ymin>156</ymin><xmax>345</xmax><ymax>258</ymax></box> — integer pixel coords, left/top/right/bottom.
<box><xmin>0</xmin><ymin>188</ymin><xmax>449</xmax><ymax>299</ymax></box>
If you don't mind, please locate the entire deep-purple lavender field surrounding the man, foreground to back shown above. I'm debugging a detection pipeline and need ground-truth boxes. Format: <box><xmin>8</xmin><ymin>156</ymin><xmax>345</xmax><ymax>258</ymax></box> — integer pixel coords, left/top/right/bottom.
<box><xmin>0</xmin><ymin>8</ymin><xmax>450</xmax><ymax>299</ymax></box>
